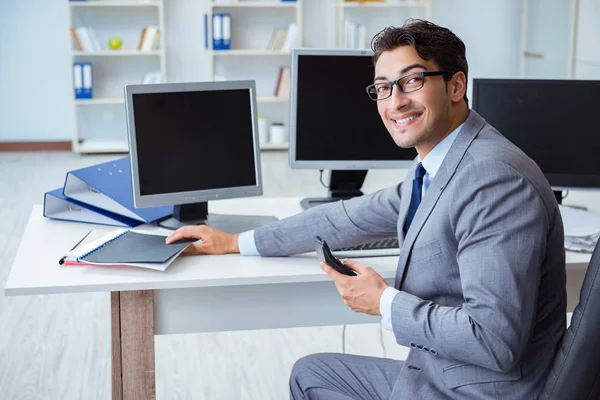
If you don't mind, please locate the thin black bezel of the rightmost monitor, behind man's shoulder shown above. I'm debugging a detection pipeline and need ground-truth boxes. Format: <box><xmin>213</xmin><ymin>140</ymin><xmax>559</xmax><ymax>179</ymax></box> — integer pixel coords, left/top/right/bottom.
<box><xmin>471</xmin><ymin>78</ymin><xmax>600</xmax><ymax>191</ymax></box>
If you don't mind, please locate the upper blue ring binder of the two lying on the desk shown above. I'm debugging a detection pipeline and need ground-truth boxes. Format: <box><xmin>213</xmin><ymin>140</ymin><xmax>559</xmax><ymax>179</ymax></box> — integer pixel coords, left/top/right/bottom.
<box><xmin>63</xmin><ymin>156</ymin><xmax>173</xmax><ymax>223</ymax></box>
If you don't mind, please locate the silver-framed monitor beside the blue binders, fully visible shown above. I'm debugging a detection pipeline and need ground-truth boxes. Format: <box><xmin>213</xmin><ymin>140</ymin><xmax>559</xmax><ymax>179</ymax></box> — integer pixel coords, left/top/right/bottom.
<box><xmin>125</xmin><ymin>81</ymin><xmax>275</xmax><ymax>232</ymax></box>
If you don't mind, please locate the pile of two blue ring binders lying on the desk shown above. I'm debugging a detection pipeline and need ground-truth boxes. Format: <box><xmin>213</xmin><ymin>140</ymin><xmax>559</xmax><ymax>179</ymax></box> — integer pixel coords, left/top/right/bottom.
<box><xmin>44</xmin><ymin>157</ymin><xmax>173</xmax><ymax>227</ymax></box>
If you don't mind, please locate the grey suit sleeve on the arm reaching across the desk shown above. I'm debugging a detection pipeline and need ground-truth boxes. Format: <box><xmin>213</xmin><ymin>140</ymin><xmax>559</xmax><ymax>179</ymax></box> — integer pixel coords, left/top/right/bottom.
<box><xmin>254</xmin><ymin>184</ymin><xmax>401</xmax><ymax>256</ymax></box>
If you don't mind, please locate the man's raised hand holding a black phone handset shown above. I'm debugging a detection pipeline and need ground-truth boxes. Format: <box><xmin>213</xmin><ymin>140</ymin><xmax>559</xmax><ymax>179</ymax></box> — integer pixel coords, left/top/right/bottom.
<box><xmin>321</xmin><ymin>260</ymin><xmax>388</xmax><ymax>315</ymax></box>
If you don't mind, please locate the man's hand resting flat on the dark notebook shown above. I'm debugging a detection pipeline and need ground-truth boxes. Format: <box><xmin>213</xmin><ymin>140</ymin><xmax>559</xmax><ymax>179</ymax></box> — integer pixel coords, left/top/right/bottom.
<box><xmin>166</xmin><ymin>225</ymin><xmax>240</xmax><ymax>254</ymax></box>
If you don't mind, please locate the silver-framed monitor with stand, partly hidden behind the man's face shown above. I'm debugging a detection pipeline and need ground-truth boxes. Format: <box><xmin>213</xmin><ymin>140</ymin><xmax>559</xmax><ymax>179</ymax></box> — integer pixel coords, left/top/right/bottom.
<box><xmin>289</xmin><ymin>49</ymin><xmax>417</xmax><ymax>208</ymax></box>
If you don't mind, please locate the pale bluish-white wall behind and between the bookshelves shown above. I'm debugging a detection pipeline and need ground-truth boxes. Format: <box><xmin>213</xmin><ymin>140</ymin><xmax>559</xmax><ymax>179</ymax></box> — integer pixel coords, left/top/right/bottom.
<box><xmin>0</xmin><ymin>0</ymin><xmax>521</xmax><ymax>141</ymax></box>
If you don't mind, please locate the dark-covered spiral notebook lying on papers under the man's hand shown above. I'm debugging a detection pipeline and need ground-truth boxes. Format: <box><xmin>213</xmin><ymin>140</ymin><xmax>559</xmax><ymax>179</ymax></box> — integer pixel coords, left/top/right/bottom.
<box><xmin>64</xmin><ymin>229</ymin><xmax>196</xmax><ymax>271</ymax></box>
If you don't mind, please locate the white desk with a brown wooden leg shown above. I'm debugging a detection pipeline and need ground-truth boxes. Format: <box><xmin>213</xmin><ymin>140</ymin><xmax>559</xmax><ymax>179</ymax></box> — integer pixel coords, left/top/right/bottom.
<box><xmin>5</xmin><ymin>198</ymin><xmax>590</xmax><ymax>400</ymax></box>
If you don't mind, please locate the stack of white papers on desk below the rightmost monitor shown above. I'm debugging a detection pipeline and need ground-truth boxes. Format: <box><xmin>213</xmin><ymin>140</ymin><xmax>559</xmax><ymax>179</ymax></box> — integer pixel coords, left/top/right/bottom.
<box><xmin>560</xmin><ymin>205</ymin><xmax>600</xmax><ymax>253</ymax></box>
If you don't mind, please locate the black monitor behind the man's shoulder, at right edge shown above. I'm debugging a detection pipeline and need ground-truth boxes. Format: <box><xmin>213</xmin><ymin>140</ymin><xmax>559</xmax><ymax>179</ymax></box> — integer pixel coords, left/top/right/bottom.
<box><xmin>472</xmin><ymin>79</ymin><xmax>600</xmax><ymax>202</ymax></box>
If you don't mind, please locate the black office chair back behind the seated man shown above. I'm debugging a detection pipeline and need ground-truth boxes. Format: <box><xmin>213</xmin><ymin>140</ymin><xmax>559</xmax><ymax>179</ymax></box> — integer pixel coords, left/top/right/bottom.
<box><xmin>539</xmin><ymin>241</ymin><xmax>600</xmax><ymax>400</ymax></box>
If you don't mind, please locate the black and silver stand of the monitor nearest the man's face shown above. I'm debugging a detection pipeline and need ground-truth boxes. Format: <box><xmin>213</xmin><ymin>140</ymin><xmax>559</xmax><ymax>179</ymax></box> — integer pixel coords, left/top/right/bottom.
<box><xmin>300</xmin><ymin>169</ymin><xmax>368</xmax><ymax>210</ymax></box>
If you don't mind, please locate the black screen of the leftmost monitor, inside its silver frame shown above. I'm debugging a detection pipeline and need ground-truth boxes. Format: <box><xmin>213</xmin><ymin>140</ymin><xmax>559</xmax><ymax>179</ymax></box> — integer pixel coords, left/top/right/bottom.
<box><xmin>132</xmin><ymin>89</ymin><xmax>256</xmax><ymax>196</ymax></box>
